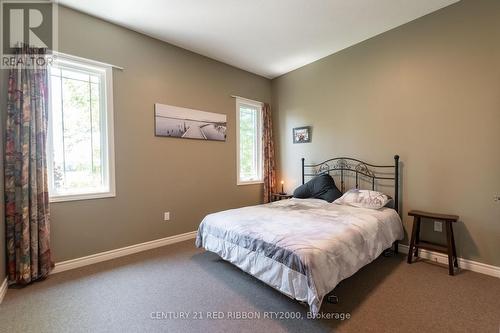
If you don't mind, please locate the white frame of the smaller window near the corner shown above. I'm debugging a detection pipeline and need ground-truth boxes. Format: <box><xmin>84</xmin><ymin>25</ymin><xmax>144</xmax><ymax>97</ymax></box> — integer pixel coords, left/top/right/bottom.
<box><xmin>236</xmin><ymin>97</ymin><xmax>264</xmax><ymax>185</ymax></box>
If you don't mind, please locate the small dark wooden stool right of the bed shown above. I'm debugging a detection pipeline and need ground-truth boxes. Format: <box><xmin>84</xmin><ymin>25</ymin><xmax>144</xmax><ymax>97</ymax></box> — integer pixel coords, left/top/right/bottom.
<box><xmin>408</xmin><ymin>210</ymin><xmax>459</xmax><ymax>275</ymax></box>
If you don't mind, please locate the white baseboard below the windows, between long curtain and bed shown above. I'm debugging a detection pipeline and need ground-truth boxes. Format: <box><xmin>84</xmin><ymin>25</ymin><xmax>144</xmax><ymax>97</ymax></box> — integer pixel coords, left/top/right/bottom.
<box><xmin>51</xmin><ymin>231</ymin><xmax>196</xmax><ymax>274</ymax></box>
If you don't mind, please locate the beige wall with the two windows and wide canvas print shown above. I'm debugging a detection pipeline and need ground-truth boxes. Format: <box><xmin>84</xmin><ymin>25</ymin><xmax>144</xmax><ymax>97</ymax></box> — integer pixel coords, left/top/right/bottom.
<box><xmin>51</xmin><ymin>7</ymin><xmax>271</xmax><ymax>261</ymax></box>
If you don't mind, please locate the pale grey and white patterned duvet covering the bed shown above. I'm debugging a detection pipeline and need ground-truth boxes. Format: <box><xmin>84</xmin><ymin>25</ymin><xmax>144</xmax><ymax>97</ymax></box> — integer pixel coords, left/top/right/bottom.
<box><xmin>196</xmin><ymin>199</ymin><xmax>403</xmax><ymax>314</ymax></box>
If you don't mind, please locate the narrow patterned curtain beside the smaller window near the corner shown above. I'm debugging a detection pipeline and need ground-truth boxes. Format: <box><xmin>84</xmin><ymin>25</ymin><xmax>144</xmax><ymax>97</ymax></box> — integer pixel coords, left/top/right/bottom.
<box><xmin>262</xmin><ymin>104</ymin><xmax>276</xmax><ymax>203</ymax></box>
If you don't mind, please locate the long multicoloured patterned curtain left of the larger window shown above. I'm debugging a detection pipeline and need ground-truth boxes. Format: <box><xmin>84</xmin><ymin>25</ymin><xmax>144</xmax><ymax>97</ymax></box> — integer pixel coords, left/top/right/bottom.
<box><xmin>4</xmin><ymin>48</ymin><xmax>53</xmax><ymax>285</ymax></box>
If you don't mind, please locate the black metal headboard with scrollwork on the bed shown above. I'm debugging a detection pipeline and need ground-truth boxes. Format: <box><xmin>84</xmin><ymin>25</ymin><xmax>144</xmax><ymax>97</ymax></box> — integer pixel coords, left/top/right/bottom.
<box><xmin>302</xmin><ymin>155</ymin><xmax>399</xmax><ymax>212</ymax></box>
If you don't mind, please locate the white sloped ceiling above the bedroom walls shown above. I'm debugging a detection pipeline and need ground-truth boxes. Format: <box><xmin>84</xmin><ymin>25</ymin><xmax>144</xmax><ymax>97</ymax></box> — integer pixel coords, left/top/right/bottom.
<box><xmin>59</xmin><ymin>0</ymin><xmax>459</xmax><ymax>78</ymax></box>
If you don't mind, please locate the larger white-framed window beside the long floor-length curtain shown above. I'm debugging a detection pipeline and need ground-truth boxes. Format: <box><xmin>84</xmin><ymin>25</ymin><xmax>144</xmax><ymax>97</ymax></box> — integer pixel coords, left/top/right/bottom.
<box><xmin>47</xmin><ymin>55</ymin><xmax>115</xmax><ymax>201</ymax></box>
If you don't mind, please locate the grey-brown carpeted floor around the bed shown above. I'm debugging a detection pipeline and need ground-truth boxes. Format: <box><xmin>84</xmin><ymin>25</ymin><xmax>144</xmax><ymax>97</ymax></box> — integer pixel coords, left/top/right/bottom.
<box><xmin>0</xmin><ymin>241</ymin><xmax>500</xmax><ymax>333</ymax></box>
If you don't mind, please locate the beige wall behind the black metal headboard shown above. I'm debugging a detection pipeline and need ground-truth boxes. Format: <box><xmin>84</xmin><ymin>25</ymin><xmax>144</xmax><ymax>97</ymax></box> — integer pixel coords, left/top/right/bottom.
<box><xmin>272</xmin><ymin>0</ymin><xmax>500</xmax><ymax>266</ymax></box>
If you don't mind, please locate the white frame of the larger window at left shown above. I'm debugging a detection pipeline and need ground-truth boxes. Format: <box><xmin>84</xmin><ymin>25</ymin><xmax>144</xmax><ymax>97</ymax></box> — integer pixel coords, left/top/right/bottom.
<box><xmin>47</xmin><ymin>53</ymin><xmax>116</xmax><ymax>202</ymax></box>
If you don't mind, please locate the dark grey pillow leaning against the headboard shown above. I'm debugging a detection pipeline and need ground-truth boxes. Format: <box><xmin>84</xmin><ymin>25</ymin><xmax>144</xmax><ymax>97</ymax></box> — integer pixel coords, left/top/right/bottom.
<box><xmin>293</xmin><ymin>173</ymin><xmax>342</xmax><ymax>202</ymax></box>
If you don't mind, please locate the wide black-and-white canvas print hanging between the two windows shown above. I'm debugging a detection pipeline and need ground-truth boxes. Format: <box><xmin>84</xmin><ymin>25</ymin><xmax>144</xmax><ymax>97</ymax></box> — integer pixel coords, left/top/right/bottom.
<box><xmin>155</xmin><ymin>103</ymin><xmax>227</xmax><ymax>141</ymax></box>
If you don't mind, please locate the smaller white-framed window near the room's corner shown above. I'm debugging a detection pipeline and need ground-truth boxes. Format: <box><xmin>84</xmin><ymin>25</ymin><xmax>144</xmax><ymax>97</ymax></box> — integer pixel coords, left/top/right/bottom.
<box><xmin>236</xmin><ymin>98</ymin><xmax>263</xmax><ymax>185</ymax></box>
